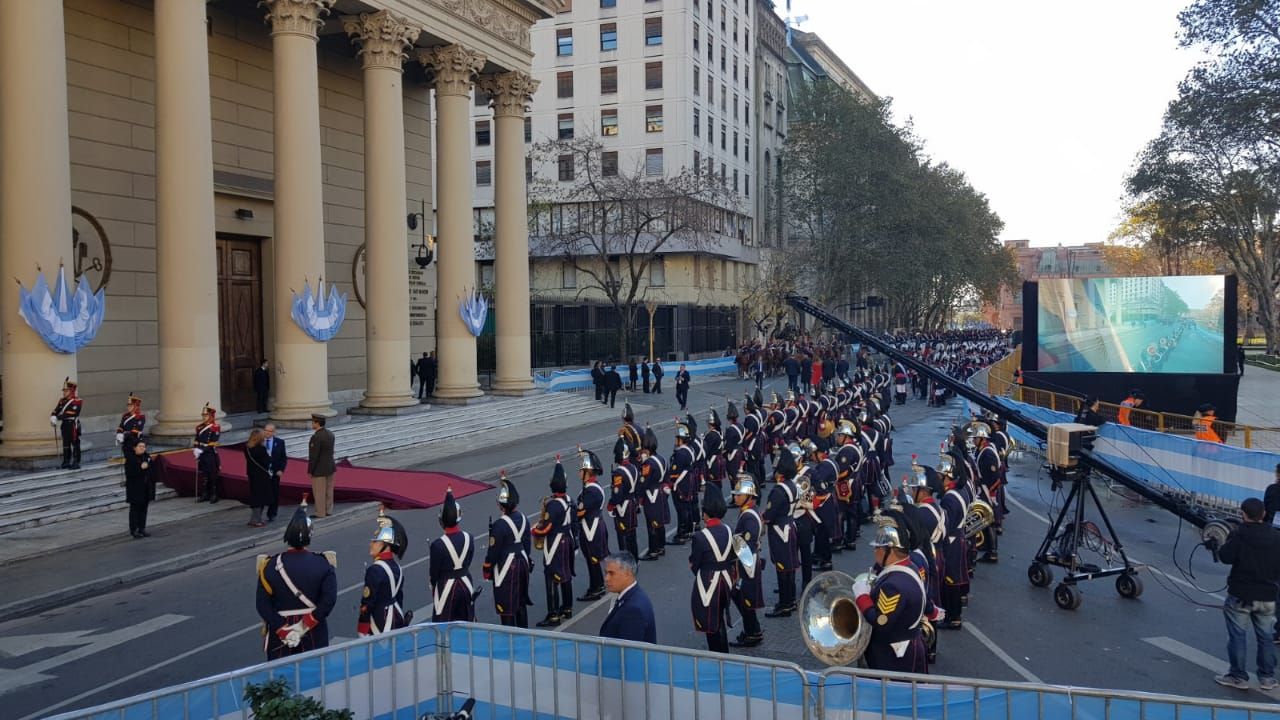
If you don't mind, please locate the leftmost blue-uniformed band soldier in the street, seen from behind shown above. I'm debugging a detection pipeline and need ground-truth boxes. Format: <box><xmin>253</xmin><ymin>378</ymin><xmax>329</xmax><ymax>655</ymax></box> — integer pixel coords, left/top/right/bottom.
<box><xmin>257</xmin><ymin>497</ymin><xmax>338</xmax><ymax>660</ymax></box>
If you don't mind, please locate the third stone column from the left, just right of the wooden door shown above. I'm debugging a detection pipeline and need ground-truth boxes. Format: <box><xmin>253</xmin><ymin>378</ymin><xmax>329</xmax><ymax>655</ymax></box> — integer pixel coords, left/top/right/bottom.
<box><xmin>264</xmin><ymin>0</ymin><xmax>335</xmax><ymax>425</ymax></box>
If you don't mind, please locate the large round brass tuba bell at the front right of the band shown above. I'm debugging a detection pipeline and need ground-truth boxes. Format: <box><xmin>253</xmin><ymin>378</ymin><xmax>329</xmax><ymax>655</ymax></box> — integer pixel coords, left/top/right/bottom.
<box><xmin>800</xmin><ymin>570</ymin><xmax>872</xmax><ymax>665</ymax></box>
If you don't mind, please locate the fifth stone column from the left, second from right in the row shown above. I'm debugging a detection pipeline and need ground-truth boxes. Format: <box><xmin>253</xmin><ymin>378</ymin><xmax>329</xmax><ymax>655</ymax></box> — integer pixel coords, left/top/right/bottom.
<box><xmin>419</xmin><ymin>45</ymin><xmax>485</xmax><ymax>402</ymax></box>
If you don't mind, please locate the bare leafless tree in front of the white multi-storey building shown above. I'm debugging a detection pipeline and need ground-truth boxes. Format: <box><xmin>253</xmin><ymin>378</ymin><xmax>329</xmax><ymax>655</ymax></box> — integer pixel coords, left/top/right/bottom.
<box><xmin>529</xmin><ymin>137</ymin><xmax>736</xmax><ymax>359</ymax></box>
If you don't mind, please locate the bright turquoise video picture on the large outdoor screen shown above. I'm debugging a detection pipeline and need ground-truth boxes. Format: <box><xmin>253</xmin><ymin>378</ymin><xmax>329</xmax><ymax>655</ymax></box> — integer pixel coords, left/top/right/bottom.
<box><xmin>1037</xmin><ymin>275</ymin><xmax>1226</xmax><ymax>373</ymax></box>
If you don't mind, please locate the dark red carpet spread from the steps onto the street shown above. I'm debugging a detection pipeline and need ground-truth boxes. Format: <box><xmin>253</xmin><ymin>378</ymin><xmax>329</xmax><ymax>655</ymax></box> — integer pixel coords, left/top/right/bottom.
<box><xmin>156</xmin><ymin>445</ymin><xmax>490</xmax><ymax>510</ymax></box>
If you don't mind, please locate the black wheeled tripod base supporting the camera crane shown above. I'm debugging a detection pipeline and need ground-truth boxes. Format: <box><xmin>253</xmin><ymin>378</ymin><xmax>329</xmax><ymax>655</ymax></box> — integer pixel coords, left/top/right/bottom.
<box><xmin>1027</xmin><ymin>466</ymin><xmax>1142</xmax><ymax>610</ymax></box>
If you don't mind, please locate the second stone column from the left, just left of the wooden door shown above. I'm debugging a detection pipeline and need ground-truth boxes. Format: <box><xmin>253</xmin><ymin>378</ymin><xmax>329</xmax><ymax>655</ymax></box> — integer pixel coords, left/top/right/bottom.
<box><xmin>151</xmin><ymin>3</ymin><xmax>221</xmax><ymax>437</ymax></box>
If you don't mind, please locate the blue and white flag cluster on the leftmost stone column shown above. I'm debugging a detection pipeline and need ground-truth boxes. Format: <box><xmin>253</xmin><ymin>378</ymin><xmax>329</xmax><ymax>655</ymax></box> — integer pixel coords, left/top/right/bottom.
<box><xmin>18</xmin><ymin>266</ymin><xmax>106</xmax><ymax>354</ymax></box>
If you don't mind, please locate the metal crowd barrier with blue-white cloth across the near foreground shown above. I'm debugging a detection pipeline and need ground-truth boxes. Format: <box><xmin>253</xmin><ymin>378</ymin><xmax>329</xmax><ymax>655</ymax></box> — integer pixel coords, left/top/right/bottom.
<box><xmin>45</xmin><ymin>623</ymin><xmax>1280</xmax><ymax>720</ymax></box>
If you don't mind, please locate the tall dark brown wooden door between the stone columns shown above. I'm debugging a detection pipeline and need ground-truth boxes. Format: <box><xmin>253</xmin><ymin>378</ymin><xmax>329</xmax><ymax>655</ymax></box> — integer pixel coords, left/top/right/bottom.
<box><xmin>218</xmin><ymin>236</ymin><xmax>264</xmax><ymax>413</ymax></box>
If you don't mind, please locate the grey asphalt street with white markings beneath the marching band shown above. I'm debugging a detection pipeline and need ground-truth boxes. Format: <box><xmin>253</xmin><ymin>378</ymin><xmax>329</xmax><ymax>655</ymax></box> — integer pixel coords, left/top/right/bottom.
<box><xmin>0</xmin><ymin>375</ymin><xmax>1270</xmax><ymax>720</ymax></box>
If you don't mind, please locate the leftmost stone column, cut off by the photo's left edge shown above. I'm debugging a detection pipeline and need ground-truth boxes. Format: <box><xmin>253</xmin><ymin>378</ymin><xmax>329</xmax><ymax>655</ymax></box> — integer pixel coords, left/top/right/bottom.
<box><xmin>0</xmin><ymin>0</ymin><xmax>76</xmax><ymax>457</ymax></box>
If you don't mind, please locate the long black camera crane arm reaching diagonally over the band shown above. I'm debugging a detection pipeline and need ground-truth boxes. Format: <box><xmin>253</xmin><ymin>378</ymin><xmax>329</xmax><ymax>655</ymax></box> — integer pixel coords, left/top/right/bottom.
<box><xmin>786</xmin><ymin>288</ymin><xmax>1225</xmax><ymax>537</ymax></box>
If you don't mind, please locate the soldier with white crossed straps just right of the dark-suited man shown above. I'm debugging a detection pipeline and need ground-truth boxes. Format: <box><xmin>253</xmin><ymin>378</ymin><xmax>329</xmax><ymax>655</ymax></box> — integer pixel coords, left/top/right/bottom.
<box><xmin>689</xmin><ymin>492</ymin><xmax>737</xmax><ymax>652</ymax></box>
